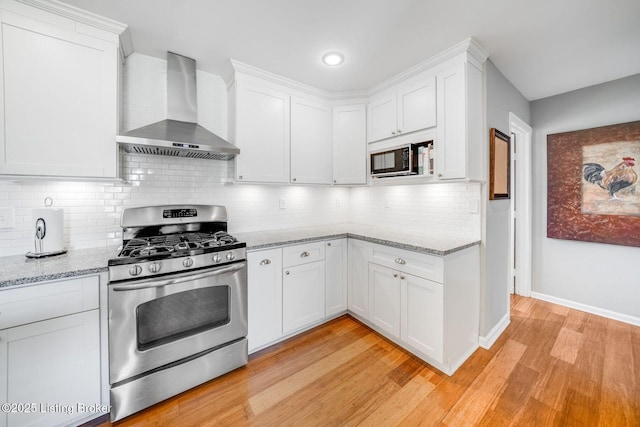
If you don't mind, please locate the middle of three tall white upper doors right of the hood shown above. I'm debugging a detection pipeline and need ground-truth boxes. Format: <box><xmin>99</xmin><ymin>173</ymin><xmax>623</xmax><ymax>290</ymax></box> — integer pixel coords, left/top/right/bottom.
<box><xmin>291</xmin><ymin>97</ymin><xmax>333</xmax><ymax>184</ymax></box>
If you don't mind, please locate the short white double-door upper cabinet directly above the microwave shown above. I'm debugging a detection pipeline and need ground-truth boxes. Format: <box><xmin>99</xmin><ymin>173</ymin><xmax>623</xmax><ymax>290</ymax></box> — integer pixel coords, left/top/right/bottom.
<box><xmin>367</xmin><ymin>73</ymin><xmax>436</xmax><ymax>142</ymax></box>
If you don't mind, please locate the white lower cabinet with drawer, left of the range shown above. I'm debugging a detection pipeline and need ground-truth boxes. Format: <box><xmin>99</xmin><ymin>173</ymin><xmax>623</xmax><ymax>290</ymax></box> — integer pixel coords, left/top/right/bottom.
<box><xmin>0</xmin><ymin>275</ymin><xmax>107</xmax><ymax>427</ymax></box>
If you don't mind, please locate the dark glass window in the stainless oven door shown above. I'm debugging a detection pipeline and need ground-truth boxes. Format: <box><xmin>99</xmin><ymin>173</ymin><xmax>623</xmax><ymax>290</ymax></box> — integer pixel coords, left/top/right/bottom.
<box><xmin>136</xmin><ymin>286</ymin><xmax>230</xmax><ymax>350</ymax></box>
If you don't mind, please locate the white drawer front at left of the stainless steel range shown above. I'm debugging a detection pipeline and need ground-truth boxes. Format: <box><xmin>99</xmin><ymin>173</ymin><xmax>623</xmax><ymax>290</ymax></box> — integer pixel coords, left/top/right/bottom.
<box><xmin>0</xmin><ymin>275</ymin><xmax>100</xmax><ymax>329</ymax></box>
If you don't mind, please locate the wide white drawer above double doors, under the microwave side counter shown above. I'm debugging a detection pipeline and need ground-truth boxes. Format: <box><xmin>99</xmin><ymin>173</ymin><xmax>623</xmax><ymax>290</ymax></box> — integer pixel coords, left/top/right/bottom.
<box><xmin>372</xmin><ymin>245</ymin><xmax>444</xmax><ymax>283</ymax></box>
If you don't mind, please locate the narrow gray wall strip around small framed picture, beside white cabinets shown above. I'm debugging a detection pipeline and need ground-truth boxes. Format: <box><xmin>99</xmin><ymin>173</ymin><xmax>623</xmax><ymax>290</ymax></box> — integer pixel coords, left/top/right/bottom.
<box><xmin>480</xmin><ymin>61</ymin><xmax>531</xmax><ymax>336</ymax></box>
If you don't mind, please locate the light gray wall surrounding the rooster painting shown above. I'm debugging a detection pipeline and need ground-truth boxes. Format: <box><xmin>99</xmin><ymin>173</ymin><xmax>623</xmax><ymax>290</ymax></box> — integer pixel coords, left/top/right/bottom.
<box><xmin>531</xmin><ymin>74</ymin><xmax>640</xmax><ymax>318</ymax></box>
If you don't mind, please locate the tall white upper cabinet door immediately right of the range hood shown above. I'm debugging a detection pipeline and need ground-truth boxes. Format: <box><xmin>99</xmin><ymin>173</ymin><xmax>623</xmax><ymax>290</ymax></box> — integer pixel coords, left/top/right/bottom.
<box><xmin>232</xmin><ymin>79</ymin><xmax>290</xmax><ymax>183</ymax></box>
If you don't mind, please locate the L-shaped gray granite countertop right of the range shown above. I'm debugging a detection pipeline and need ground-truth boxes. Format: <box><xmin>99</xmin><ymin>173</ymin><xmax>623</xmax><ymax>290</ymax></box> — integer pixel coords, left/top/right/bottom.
<box><xmin>231</xmin><ymin>223</ymin><xmax>480</xmax><ymax>256</ymax></box>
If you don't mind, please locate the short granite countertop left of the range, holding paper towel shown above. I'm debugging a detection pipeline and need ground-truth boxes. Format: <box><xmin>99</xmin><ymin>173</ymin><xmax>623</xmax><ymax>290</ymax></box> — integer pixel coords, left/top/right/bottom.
<box><xmin>0</xmin><ymin>246</ymin><xmax>117</xmax><ymax>289</ymax></box>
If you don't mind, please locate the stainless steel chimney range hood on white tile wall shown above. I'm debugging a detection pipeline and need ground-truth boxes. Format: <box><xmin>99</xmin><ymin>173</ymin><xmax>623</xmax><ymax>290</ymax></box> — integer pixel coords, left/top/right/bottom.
<box><xmin>116</xmin><ymin>52</ymin><xmax>240</xmax><ymax>160</ymax></box>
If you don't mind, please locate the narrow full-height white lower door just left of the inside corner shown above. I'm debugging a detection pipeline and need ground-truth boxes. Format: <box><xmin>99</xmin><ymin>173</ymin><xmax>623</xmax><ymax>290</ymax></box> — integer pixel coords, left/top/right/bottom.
<box><xmin>325</xmin><ymin>239</ymin><xmax>348</xmax><ymax>316</ymax></box>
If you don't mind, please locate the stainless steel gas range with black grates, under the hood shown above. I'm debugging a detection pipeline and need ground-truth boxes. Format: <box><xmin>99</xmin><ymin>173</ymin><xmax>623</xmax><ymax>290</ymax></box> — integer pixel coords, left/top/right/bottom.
<box><xmin>108</xmin><ymin>205</ymin><xmax>248</xmax><ymax>421</ymax></box>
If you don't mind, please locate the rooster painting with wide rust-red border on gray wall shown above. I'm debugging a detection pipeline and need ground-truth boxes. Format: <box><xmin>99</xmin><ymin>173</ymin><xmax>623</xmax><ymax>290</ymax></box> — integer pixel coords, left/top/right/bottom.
<box><xmin>547</xmin><ymin>121</ymin><xmax>640</xmax><ymax>246</ymax></box>
